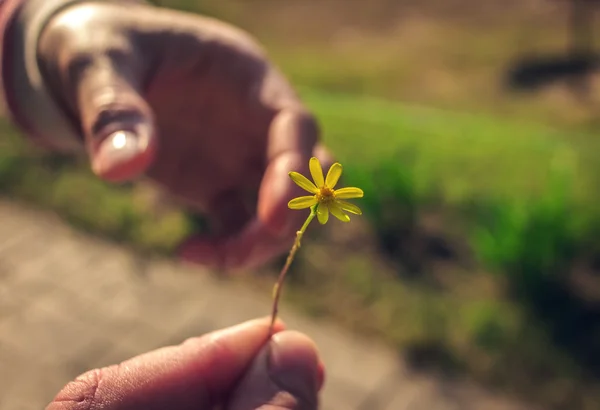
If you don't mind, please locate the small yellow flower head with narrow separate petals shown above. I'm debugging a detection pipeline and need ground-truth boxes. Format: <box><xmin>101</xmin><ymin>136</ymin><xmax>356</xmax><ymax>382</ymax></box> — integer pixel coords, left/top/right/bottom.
<box><xmin>288</xmin><ymin>157</ymin><xmax>364</xmax><ymax>224</ymax></box>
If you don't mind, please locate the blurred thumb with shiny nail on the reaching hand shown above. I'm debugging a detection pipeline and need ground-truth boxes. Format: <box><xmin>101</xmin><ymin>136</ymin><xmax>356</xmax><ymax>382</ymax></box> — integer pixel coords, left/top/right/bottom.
<box><xmin>77</xmin><ymin>51</ymin><xmax>157</xmax><ymax>182</ymax></box>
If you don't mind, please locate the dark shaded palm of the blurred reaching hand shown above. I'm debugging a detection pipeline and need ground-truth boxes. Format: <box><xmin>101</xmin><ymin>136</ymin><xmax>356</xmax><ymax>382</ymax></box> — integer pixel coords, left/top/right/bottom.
<box><xmin>140</xmin><ymin>20</ymin><xmax>299</xmax><ymax>235</ymax></box>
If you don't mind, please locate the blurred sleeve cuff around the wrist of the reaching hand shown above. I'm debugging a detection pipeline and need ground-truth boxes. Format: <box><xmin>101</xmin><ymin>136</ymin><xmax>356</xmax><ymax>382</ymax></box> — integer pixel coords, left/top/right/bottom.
<box><xmin>0</xmin><ymin>0</ymin><xmax>144</xmax><ymax>153</ymax></box>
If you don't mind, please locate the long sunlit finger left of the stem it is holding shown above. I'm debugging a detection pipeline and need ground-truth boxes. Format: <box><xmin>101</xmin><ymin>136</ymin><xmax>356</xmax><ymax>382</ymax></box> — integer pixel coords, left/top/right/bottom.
<box><xmin>46</xmin><ymin>318</ymin><xmax>283</xmax><ymax>410</ymax></box>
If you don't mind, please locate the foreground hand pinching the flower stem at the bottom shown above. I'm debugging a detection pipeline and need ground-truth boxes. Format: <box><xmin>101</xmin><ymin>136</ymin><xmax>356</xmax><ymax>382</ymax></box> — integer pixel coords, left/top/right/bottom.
<box><xmin>46</xmin><ymin>319</ymin><xmax>323</xmax><ymax>410</ymax></box>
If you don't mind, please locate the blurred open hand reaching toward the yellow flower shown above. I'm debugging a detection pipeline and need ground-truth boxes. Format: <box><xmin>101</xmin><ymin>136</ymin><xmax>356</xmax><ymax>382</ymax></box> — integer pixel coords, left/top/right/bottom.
<box><xmin>38</xmin><ymin>2</ymin><xmax>332</xmax><ymax>268</ymax></box>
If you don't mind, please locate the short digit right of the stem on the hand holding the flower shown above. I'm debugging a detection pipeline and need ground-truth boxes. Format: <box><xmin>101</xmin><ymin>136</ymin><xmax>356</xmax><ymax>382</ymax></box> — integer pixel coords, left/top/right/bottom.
<box><xmin>226</xmin><ymin>331</ymin><xmax>322</xmax><ymax>410</ymax></box>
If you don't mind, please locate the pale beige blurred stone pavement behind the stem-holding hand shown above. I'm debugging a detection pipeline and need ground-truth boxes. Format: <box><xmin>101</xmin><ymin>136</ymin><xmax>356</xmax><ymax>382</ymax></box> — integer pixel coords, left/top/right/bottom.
<box><xmin>0</xmin><ymin>201</ymin><xmax>528</xmax><ymax>410</ymax></box>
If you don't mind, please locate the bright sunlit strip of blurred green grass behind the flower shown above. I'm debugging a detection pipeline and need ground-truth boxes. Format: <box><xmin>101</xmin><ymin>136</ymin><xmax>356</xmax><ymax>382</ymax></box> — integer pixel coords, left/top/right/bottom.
<box><xmin>303</xmin><ymin>91</ymin><xmax>600</xmax><ymax>204</ymax></box>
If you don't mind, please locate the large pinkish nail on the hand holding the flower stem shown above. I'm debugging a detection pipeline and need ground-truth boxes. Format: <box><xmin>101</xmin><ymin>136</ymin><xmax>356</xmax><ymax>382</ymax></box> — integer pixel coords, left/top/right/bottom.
<box><xmin>269</xmin><ymin>331</ymin><xmax>319</xmax><ymax>403</ymax></box>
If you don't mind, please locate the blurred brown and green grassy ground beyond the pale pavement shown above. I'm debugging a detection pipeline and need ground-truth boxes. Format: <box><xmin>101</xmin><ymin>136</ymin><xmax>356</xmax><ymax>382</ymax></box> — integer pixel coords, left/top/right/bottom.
<box><xmin>0</xmin><ymin>0</ymin><xmax>600</xmax><ymax>410</ymax></box>
